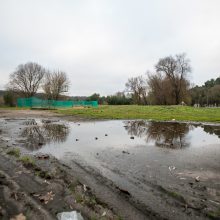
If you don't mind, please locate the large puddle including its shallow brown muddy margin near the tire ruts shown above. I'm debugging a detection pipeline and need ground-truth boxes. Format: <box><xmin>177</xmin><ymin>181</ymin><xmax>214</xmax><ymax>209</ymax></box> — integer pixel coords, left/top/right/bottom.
<box><xmin>2</xmin><ymin>119</ymin><xmax>220</xmax><ymax>216</ymax></box>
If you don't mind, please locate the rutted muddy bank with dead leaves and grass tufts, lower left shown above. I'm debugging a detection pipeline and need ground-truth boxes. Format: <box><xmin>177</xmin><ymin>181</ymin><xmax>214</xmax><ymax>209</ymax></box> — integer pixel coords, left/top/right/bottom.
<box><xmin>0</xmin><ymin>144</ymin><xmax>120</xmax><ymax>219</ymax></box>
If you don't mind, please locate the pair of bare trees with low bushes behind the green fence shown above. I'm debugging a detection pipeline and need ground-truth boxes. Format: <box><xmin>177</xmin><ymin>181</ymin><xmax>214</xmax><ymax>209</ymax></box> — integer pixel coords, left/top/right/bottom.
<box><xmin>4</xmin><ymin>62</ymin><xmax>70</xmax><ymax>106</ymax></box>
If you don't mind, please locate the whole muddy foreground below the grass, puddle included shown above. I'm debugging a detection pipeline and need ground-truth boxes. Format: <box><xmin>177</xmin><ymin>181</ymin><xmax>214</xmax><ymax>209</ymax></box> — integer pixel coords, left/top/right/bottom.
<box><xmin>0</xmin><ymin>110</ymin><xmax>220</xmax><ymax>219</ymax></box>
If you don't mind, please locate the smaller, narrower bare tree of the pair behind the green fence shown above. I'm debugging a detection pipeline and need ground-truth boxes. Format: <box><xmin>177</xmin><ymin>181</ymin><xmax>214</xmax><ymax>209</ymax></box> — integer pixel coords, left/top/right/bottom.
<box><xmin>42</xmin><ymin>71</ymin><xmax>70</xmax><ymax>100</ymax></box>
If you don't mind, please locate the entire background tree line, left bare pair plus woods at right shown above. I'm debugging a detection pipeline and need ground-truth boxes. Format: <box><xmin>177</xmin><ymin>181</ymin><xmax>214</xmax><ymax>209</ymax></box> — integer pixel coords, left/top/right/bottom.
<box><xmin>4</xmin><ymin>53</ymin><xmax>220</xmax><ymax>106</ymax></box>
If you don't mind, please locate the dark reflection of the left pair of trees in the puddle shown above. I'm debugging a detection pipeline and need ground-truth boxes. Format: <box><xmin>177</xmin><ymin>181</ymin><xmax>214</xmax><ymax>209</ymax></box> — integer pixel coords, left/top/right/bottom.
<box><xmin>21</xmin><ymin>123</ymin><xmax>69</xmax><ymax>150</ymax></box>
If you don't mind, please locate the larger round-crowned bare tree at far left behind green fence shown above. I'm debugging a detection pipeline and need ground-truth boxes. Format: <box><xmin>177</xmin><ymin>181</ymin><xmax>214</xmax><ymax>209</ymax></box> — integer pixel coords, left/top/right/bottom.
<box><xmin>8</xmin><ymin>62</ymin><xmax>45</xmax><ymax>97</ymax></box>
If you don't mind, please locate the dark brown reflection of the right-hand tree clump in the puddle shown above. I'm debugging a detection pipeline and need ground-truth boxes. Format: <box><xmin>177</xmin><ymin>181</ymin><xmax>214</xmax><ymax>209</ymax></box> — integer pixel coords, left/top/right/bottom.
<box><xmin>124</xmin><ymin>121</ymin><xmax>191</xmax><ymax>148</ymax></box>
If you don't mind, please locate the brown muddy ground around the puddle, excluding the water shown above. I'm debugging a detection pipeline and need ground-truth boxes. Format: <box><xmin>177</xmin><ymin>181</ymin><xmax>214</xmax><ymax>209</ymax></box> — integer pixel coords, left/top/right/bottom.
<box><xmin>0</xmin><ymin>110</ymin><xmax>220</xmax><ymax>220</ymax></box>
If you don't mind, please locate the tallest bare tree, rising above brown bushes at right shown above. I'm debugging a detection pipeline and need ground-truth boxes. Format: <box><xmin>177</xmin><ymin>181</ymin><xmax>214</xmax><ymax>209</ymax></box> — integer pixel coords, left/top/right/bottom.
<box><xmin>155</xmin><ymin>53</ymin><xmax>191</xmax><ymax>104</ymax></box>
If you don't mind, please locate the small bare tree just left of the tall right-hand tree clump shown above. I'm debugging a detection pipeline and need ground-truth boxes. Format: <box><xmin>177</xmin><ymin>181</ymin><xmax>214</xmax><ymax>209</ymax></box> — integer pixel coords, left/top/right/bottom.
<box><xmin>125</xmin><ymin>76</ymin><xmax>147</xmax><ymax>104</ymax></box>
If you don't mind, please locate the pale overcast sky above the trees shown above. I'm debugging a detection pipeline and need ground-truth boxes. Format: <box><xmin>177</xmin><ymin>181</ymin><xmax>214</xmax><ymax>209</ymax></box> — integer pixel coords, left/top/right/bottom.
<box><xmin>0</xmin><ymin>0</ymin><xmax>220</xmax><ymax>95</ymax></box>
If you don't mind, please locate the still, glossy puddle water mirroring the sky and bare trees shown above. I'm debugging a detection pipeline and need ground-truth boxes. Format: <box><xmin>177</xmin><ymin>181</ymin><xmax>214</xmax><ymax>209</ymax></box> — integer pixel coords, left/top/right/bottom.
<box><xmin>19</xmin><ymin>120</ymin><xmax>220</xmax><ymax>178</ymax></box>
